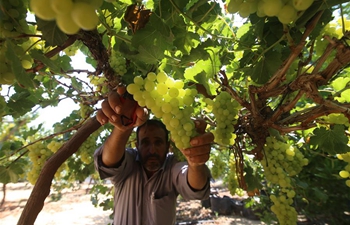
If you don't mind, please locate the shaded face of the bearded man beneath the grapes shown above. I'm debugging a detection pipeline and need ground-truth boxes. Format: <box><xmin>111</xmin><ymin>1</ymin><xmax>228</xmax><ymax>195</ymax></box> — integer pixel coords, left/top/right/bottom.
<box><xmin>136</xmin><ymin>125</ymin><xmax>169</xmax><ymax>175</ymax></box>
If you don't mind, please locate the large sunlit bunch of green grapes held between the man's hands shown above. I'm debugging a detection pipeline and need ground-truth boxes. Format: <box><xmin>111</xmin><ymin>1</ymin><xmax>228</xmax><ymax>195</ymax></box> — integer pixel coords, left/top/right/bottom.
<box><xmin>127</xmin><ymin>72</ymin><xmax>197</xmax><ymax>149</ymax></box>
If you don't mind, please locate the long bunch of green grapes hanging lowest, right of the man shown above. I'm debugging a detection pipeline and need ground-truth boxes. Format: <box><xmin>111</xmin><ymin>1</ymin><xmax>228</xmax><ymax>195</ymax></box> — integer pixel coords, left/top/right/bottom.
<box><xmin>261</xmin><ymin>137</ymin><xmax>308</xmax><ymax>224</ymax></box>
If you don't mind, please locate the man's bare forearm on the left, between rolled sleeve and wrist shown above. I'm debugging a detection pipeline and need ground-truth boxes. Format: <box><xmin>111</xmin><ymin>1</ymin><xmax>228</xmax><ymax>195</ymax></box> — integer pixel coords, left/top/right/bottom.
<box><xmin>102</xmin><ymin>128</ymin><xmax>132</xmax><ymax>167</ymax></box>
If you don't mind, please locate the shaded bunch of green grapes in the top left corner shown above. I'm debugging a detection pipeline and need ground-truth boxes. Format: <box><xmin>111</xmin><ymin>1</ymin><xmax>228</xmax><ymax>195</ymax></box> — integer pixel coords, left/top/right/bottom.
<box><xmin>0</xmin><ymin>0</ymin><xmax>29</xmax><ymax>39</ymax></box>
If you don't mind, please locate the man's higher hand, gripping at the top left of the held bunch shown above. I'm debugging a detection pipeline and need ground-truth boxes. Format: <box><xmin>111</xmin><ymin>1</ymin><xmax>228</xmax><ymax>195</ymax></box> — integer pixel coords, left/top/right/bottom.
<box><xmin>96</xmin><ymin>87</ymin><xmax>148</xmax><ymax>131</ymax></box>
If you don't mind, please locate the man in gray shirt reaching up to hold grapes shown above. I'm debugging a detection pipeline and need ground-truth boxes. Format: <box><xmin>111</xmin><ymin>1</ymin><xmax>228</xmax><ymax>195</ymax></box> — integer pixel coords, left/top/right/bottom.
<box><xmin>95</xmin><ymin>89</ymin><xmax>214</xmax><ymax>225</ymax></box>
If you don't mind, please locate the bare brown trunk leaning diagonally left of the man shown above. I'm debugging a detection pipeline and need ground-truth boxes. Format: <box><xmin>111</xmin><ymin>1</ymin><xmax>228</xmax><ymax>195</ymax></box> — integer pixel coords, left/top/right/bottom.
<box><xmin>17</xmin><ymin>117</ymin><xmax>101</xmax><ymax>225</ymax></box>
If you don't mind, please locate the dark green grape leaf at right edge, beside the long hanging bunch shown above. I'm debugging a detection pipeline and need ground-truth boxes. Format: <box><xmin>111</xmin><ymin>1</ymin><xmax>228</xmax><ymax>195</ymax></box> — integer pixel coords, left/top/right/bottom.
<box><xmin>310</xmin><ymin>125</ymin><xmax>350</xmax><ymax>155</ymax></box>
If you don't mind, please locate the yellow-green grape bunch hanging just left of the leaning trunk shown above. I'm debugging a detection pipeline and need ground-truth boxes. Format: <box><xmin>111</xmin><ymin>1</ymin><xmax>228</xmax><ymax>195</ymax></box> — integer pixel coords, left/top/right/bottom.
<box><xmin>27</xmin><ymin>142</ymin><xmax>52</xmax><ymax>185</ymax></box>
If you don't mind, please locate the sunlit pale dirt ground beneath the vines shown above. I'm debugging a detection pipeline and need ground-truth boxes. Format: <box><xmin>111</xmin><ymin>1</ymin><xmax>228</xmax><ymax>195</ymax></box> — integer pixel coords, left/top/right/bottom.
<box><xmin>0</xmin><ymin>183</ymin><xmax>264</xmax><ymax>225</ymax></box>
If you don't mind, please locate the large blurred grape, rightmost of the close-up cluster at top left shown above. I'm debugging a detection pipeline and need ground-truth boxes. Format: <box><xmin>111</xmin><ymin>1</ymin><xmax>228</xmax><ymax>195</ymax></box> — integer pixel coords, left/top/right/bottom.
<box><xmin>71</xmin><ymin>2</ymin><xmax>99</xmax><ymax>30</ymax></box>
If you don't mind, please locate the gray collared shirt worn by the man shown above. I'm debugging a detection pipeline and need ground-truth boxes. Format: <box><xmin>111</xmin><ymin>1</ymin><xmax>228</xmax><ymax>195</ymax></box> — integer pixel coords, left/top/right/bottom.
<box><xmin>94</xmin><ymin>147</ymin><xmax>210</xmax><ymax>225</ymax></box>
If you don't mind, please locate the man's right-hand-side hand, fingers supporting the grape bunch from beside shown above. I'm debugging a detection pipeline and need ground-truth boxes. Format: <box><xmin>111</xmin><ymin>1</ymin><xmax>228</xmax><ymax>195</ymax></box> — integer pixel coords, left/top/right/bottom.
<box><xmin>181</xmin><ymin>120</ymin><xmax>214</xmax><ymax>167</ymax></box>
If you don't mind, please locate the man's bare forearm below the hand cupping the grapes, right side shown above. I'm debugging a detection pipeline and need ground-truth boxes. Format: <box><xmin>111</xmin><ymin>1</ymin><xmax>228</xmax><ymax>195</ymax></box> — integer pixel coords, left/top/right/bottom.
<box><xmin>187</xmin><ymin>164</ymin><xmax>209</xmax><ymax>190</ymax></box>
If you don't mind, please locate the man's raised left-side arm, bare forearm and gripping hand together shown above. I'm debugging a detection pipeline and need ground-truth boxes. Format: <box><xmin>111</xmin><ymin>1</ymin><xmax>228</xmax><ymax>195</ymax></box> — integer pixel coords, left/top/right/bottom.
<box><xmin>96</xmin><ymin>88</ymin><xmax>148</xmax><ymax>167</ymax></box>
